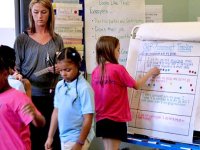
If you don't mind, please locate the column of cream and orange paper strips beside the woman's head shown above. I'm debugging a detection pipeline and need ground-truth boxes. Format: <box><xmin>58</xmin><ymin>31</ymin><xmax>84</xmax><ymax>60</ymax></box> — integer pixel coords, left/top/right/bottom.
<box><xmin>52</xmin><ymin>0</ymin><xmax>84</xmax><ymax>56</ymax></box>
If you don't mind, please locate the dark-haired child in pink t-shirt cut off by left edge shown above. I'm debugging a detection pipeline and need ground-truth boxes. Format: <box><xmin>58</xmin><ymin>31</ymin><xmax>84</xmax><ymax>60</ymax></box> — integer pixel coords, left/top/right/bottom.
<box><xmin>0</xmin><ymin>45</ymin><xmax>45</xmax><ymax>150</ymax></box>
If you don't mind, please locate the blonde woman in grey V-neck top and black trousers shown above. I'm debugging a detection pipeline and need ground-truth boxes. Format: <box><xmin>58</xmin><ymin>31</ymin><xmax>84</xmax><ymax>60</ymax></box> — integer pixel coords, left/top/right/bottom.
<box><xmin>14</xmin><ymin>0</ymin><xmax>63</xmax><ymax>150</ymax></box>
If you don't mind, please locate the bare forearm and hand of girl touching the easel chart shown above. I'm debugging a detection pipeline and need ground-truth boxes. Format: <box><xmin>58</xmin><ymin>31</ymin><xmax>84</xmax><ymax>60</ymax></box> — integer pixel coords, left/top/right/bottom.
<box><xmin>134</xmin><ymin>67</ymin><xmax>160</xmax><ymax>90</ymax></box>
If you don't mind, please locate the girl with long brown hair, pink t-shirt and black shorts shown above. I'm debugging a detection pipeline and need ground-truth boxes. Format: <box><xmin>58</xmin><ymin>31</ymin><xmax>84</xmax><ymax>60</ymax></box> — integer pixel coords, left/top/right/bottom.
<box><xmin>92</xmin><ymin>36</ymin><xmax>160</xmax><ymax>150</ymax></box>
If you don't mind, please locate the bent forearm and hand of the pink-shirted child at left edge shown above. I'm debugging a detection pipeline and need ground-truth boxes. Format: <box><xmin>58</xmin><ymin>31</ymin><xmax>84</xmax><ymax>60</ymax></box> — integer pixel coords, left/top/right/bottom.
<box><xmin>22</xmin><ymin>103</ymin><xmax>46</xmax><ymax>127</ymax></box>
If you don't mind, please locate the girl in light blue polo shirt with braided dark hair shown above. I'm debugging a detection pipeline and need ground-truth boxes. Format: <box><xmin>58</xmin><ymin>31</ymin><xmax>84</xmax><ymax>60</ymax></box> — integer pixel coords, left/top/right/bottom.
<box><xmin>45</xmin><ymin>47</ymin><xmax>95</xmax><ymax>150</ymax></box>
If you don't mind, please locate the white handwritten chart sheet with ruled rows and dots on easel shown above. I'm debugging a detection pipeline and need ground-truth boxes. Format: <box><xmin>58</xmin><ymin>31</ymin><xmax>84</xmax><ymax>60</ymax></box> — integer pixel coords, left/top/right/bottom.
<box><xmin>127</xmin><ymin>39</ymin><xmax>200</xmax><ymax>143</ymax></box>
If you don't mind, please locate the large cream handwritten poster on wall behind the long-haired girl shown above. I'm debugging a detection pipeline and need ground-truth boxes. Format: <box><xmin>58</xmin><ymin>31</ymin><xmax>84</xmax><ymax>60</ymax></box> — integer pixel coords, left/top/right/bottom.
<box><xmin>85</xmin><ymin>0</ymin><xmax>145</xmax><ymax>74</ymax></box>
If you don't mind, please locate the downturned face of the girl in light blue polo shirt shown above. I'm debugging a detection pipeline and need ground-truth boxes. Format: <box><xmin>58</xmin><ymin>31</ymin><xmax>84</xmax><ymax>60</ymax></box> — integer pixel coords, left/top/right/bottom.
<box><xmin>58</xmin><ymin>60</ymin><xmax>79</xmax><ymax>82</ymax></box>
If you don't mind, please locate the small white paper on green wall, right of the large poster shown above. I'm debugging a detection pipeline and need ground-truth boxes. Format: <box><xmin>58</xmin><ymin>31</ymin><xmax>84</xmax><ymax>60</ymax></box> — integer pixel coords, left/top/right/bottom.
<box><xmin>145</xmin><ymin>5</ymin><xmax>163</xmax><ymax>22</ymax></box>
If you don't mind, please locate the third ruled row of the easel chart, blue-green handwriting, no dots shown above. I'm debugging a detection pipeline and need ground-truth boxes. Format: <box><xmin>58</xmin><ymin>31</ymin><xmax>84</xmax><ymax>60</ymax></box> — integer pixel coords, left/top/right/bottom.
<box><xmin>130</xmin><ymin>91</ymin><xmax>195</xmax><ymax>116</ymax></box>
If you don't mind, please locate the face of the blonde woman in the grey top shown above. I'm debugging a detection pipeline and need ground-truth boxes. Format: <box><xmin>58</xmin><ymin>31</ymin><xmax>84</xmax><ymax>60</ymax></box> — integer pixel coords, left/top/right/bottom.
<box><xmin>31</xmin><ymin>3</ymin><xmax>49</xmax><ymax>26</ymax></box>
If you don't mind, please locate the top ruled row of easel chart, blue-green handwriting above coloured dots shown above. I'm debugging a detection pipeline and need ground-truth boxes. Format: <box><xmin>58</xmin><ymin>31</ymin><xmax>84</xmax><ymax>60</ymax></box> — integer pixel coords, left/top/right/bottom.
<box><xmin>137</xmin><ymin>56</ymin><xmax>200</xmax><ymax>75</ymax></box>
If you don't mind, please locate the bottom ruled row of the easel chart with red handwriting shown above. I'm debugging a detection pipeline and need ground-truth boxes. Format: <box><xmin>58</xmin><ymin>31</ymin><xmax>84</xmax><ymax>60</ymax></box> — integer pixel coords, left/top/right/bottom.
<box><xmin>128</xmin><ymin>111</ymin><xmax>190</xmax><ymax>135</ymax></box>
